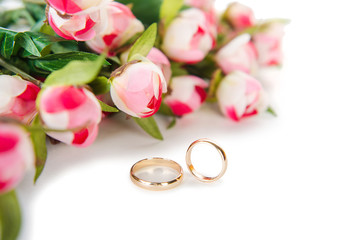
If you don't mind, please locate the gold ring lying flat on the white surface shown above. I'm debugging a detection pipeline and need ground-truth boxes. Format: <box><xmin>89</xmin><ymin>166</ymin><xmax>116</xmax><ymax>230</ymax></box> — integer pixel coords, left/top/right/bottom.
<box><xmin>130</xmin><ymin>157</ymin><xmax>183</xmax><ymax>191</ymax></box>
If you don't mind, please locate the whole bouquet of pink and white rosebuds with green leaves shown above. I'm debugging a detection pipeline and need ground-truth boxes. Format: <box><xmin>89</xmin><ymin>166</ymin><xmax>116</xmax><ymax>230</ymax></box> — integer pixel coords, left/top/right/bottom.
<box><xmin>0</xmin><ymin>0</ymin><xmax>286</xmax><ymax>239</ymax></box>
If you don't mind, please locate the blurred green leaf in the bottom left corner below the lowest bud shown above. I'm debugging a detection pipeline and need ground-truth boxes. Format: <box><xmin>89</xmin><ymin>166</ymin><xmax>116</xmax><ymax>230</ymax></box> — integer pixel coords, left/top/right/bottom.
<box><xmin>0</xmin><ymin>191</ymin><xmax>21</xmax><ymax>240</ymax></box>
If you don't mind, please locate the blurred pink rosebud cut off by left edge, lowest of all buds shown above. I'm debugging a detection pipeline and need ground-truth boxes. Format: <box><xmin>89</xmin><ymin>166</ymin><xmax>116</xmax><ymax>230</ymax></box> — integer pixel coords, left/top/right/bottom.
<box><xmin>0</xmin><ymin>123</ymin><xmax>35</xmax><ymax>194</ymax></box>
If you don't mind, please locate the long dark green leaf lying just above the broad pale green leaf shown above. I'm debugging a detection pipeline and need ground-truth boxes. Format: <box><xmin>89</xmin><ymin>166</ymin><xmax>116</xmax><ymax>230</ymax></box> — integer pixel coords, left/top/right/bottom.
<box><xmin>28</xmin><ymin>52</ymin><xmax>110</xmax><ymax>74</ymax></box>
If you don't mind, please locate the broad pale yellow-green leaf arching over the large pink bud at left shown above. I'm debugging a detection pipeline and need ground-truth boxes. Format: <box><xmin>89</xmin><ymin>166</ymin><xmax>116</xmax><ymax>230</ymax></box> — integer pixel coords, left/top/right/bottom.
<box><xmin>43</xmin><ymin>55</ymin><xmax>105</xmax><ymax>87</ymax></box>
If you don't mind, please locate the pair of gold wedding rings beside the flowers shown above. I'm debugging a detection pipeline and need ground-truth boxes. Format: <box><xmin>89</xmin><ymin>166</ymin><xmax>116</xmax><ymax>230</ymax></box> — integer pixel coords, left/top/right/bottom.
<box><xmin>130</xmin><ymin>138</ymin><xmax>227</xmax><ymax>191</ymax></box>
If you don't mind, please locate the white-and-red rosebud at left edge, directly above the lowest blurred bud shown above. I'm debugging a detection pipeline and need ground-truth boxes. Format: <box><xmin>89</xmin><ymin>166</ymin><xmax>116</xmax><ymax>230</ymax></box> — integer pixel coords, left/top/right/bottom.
<box><xmin>0</xmin><ymin>75</ymin><xmax>40</xmax><ymax>124</ymax></box>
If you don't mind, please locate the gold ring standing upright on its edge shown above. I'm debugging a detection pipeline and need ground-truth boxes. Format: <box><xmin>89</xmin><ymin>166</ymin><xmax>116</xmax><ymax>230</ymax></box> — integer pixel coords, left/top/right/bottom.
<box><xmin>186</xmin><ymin>138</ymin><xmax>227</xmax><ymax>182</ymax></box>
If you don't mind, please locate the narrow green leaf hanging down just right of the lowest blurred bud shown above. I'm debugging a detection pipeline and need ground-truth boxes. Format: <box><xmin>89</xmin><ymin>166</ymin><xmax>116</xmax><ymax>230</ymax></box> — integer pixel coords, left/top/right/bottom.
<box><xmin>31</xmin><ymin>115</ymin><xmax>47</xmax><ymax>183</ymax></box>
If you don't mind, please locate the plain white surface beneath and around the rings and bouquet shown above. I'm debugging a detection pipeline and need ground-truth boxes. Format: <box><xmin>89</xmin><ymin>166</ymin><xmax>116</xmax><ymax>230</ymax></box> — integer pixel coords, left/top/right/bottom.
<box><xmin>13</xmin><ymin>0</ymin><xmax>362</xmax><ymax>240</ymax></box>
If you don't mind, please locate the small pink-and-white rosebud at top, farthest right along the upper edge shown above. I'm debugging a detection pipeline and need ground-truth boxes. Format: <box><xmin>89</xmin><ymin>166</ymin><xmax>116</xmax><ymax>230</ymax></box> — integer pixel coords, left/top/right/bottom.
<box><xmin>224</xmin><ymin>2</ymin><xmax>256</xmax><ymax>31</ymax></box>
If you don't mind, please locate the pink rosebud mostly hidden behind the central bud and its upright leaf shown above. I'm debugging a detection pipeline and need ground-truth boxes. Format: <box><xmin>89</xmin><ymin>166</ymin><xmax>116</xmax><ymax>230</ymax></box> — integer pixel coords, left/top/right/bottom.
<box><xmin>121</xmin><ymin>48</ymin><xmax>172</xmax><ymax>83</ymax></box>
